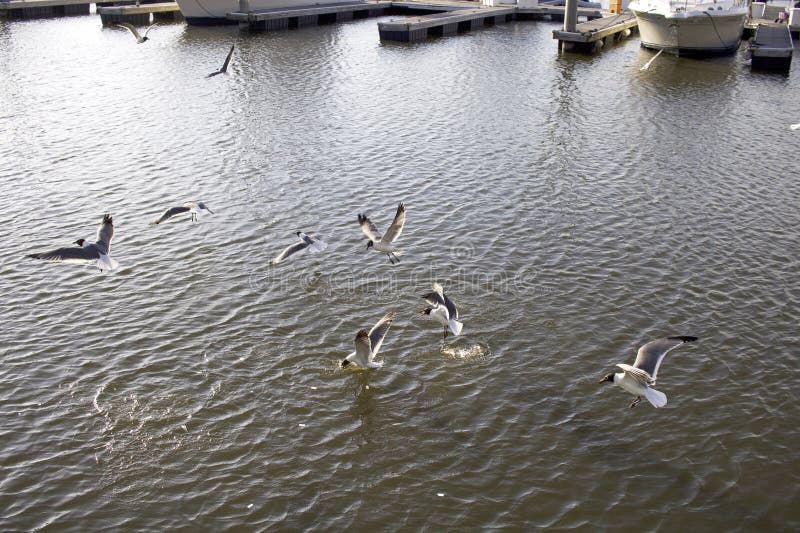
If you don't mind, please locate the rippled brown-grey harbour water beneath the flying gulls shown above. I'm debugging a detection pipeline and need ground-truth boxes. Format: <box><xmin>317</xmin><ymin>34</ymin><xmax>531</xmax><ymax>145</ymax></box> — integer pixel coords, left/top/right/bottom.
<box><xmin>0</xmin><ymin>10</ymin><xmax>800</xmax><ymax>531</ymax></box>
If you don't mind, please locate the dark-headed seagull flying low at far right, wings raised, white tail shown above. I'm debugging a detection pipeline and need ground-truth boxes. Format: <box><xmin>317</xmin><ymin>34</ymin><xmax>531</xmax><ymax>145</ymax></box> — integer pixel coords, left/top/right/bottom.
<box><xmin>600</xmin><ymin>336</ymin><xmax>697</xmax><ymax>407</ymax></box>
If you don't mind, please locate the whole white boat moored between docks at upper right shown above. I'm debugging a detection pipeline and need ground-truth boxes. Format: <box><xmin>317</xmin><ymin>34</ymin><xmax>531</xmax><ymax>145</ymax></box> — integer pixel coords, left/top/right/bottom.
<box><xmin>628</xmin><ymin>0</ymin><xmax>748</xmax><ymax>55</ymax></box>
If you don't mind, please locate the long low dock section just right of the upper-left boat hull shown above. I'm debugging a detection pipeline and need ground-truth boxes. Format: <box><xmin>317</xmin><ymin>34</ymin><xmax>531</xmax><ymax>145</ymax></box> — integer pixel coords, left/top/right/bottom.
<box><xmin>226</xmin><ymin>2</ymin><xmax>392</xmax><ymax>32</ymax></box>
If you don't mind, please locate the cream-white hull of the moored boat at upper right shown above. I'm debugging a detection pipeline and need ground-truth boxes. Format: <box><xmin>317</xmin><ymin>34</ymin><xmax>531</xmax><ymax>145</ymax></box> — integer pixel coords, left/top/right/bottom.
<box><xmin>632</xmin><ymin>9</ymin><xmax>747</xmax><ymax>56</ymax></box>
